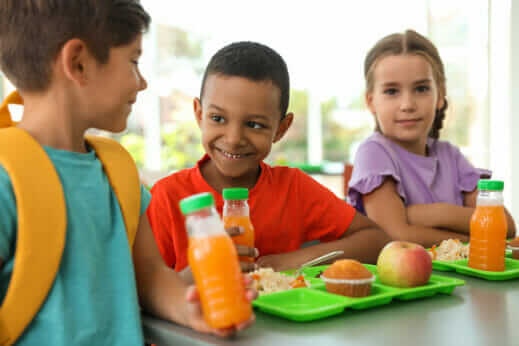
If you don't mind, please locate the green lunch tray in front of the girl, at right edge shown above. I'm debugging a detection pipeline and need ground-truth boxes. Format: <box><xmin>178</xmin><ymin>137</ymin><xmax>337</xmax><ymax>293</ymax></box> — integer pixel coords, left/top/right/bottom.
<box><xmin>433</xmin><ymin>254</ymin><xmax>519</xmax><ymax>281</ymax></box>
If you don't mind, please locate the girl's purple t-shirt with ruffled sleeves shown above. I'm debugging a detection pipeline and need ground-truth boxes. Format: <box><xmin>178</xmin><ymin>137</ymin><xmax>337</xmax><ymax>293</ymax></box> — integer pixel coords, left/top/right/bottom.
<box><xmin>348</xmin><ymin>132</ymin><xmax>491</xmax><ymax>213</ymax></box>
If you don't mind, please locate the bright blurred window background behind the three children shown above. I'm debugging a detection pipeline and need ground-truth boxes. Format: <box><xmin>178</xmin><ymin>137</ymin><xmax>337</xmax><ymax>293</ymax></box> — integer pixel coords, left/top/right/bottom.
<box><xmin>0</xmin><ymin>0</ymin><xmax>519</xmax><ymax>212</ymax></box>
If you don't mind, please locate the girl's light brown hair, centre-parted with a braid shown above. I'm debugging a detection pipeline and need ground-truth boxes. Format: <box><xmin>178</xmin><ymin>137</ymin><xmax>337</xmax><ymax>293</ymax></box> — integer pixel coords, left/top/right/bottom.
<box><xmin>364</xmin><ymin>30</ymin><xmax>448</xmax><ymax>139</ymax></box>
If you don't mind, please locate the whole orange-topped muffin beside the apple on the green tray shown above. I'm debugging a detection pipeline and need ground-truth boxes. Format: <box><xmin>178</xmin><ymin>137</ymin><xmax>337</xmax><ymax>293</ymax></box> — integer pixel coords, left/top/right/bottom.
<box><xmin>321</xmin><ymin>259</ymin><xmax>375</xmax><ymax>298</ymax></box>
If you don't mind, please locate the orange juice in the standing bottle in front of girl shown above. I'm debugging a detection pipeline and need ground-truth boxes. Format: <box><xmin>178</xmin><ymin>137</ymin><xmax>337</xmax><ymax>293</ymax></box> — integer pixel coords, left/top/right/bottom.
<box><xmin>468</xmin><ymin>206</ymin><xmax>508</xmax><ymax>272</ymax></box>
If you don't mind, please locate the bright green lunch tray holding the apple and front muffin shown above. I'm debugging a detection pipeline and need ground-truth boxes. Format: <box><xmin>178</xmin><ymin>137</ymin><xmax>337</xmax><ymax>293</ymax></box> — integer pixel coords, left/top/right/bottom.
<box><xmin>252</xmin><ymin>264</ymin><xmax>465</xmax><ymax>322</ymax></box>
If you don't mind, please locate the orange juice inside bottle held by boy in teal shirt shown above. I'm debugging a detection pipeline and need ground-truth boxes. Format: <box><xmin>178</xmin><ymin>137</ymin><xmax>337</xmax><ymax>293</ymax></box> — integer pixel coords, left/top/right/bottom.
<box><xmin>188</xmin><ymin>234</ymin><xmax>252</xmax><ymax>328</ymax></box>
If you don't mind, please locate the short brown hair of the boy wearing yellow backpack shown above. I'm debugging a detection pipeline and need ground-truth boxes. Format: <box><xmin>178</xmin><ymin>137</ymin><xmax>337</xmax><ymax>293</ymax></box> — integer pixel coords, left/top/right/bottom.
<box><xmin>0</xmin><ymin>0</ymin><xmax>150</xmax><ymax>91</ymax></box>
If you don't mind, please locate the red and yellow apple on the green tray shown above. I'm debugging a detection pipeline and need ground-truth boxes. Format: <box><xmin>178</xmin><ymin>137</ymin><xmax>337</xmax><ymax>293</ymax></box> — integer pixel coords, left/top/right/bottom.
<box><xmin>377</xmin><ymin>241</ymin><xmax>432</xmax><ymax>287</ymax></box>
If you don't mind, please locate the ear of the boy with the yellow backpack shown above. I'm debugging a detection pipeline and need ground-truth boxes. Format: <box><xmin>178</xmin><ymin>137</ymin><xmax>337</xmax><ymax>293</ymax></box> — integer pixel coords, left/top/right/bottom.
<box><xmin>58</xmin><ymin>39</ymin><xmax>93</xmax><ymax>85</ymax></box>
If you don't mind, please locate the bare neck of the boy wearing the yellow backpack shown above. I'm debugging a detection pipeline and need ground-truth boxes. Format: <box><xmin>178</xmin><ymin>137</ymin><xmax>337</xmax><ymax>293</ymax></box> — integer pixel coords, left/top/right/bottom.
<box><xmin>18</xmin><ymin>92</ymin><xmax>87</xmax><ymax>153</ymax></box>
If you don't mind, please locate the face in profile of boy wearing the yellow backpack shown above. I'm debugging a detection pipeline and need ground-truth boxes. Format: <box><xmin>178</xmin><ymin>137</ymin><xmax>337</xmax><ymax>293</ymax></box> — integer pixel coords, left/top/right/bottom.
<box><xmin>86</xmin><ymin>35</ymin><xmax>147</xmax><ymax>132</ymax></box>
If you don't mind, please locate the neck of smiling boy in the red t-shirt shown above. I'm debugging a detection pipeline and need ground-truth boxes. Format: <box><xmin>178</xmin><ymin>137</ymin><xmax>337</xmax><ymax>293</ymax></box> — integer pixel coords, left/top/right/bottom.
<box><xmin>200</xmin><ymin>160</ymin><xmax>261</xmax><ymax>194</ymax></box>
